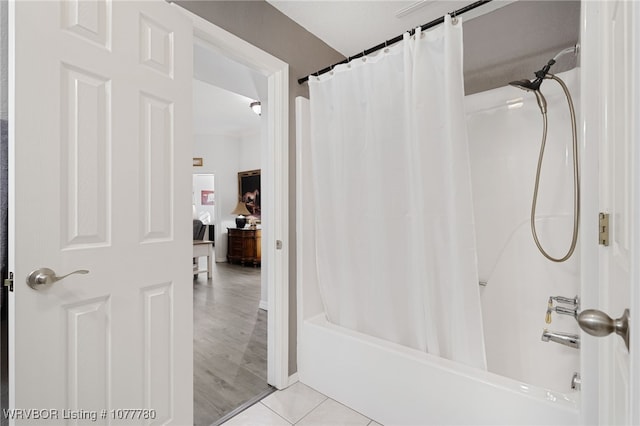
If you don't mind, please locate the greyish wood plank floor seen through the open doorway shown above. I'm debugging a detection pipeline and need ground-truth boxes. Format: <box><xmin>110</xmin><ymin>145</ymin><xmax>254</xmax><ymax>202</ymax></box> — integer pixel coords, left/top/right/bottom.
<box><xmin>193</xmin><ymin>263</ymin><xmax>270</xmax><ymax>426</ymax></box>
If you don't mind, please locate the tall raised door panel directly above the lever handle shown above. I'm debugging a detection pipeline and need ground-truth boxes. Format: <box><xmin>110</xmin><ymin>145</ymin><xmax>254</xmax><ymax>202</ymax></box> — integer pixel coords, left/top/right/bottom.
<box><xmin>60</xmin><ymin>64</ymin><xmax>111</xmax><ymax>248</ymax></box>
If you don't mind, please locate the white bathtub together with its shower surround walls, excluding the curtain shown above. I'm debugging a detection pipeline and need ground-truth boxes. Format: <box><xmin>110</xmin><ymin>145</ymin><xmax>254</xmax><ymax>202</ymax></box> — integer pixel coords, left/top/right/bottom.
<box><xmin>296</xmin><ymin>68</ymin><xmax>580</xmax><ymax>425</ymax></box>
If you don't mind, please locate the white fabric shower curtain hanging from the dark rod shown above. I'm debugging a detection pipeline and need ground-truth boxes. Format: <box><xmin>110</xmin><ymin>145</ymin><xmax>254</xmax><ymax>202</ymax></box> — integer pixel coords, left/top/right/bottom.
<box><xmin>309</xmin><ymin>16</ymin><xmax>486</xmax><ymax>369</ymax></box>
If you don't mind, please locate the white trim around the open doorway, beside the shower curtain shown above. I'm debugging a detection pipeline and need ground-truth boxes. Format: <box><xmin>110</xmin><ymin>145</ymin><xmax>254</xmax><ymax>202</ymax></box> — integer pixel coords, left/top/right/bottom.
<box><xmin>174</xmin><ymin>4</ymin><xmax>289</xmax><ymax>389</ymax></box>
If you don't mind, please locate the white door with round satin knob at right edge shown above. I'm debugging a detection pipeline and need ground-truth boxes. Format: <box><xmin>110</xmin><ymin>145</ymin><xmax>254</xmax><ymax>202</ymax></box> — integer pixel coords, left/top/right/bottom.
<box><xmin>581</xmin><ymin>0</ymin><xmax>640</xmax><ymax>425</ymax></box>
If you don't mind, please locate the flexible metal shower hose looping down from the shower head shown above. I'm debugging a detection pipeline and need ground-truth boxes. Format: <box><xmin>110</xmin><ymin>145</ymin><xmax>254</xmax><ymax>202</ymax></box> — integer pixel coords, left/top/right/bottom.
<box><xmin>531</xmin><ymin>74</ymin><xmax>580</xmax><ymax>262</ymax></box>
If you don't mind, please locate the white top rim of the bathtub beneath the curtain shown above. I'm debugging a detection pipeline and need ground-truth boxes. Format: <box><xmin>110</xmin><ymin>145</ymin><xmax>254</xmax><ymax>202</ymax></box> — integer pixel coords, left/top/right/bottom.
<box><xmin>299</xmin><ymin>312</ymin><xmax>580</xmax><ymax>413</ymax></box>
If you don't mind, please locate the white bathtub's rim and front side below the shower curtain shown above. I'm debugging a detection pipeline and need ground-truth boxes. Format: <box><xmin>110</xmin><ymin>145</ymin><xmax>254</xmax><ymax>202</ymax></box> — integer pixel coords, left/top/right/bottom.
<box><xmin>298</xmin><ymin>314</ymin><xmax>579</xmax><ymax>425</ymax></box>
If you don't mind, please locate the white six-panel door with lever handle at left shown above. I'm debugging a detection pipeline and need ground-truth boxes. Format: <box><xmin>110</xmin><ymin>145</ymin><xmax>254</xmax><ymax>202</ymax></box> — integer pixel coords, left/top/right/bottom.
<box><xmin>8</xmin><ymin>0</ymin><xmax>193</xmax><ymax>425</ymax></box>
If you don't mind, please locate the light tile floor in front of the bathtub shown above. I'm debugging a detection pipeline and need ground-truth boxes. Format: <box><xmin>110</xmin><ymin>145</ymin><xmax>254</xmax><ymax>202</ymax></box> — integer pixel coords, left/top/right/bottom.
<box><xmin>224</xmin><ymin>382</ymin><xmax>380</xmax><ymax>426</ymax></box>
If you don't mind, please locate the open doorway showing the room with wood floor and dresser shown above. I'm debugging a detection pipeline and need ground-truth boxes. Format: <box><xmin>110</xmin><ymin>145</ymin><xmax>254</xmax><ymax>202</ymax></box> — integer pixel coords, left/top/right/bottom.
<box><xmin>192</xmin><ymin>78</ymin><xmax>273</xmax><ymax>426</ymax></box>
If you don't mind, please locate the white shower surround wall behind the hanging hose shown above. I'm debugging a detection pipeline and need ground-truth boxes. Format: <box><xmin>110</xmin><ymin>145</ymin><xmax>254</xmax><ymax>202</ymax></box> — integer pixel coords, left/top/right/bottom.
<box><xmin>466</xmin><ymin>69</ymin><xmax>580</xmax><ymax>392</ymax></box>
